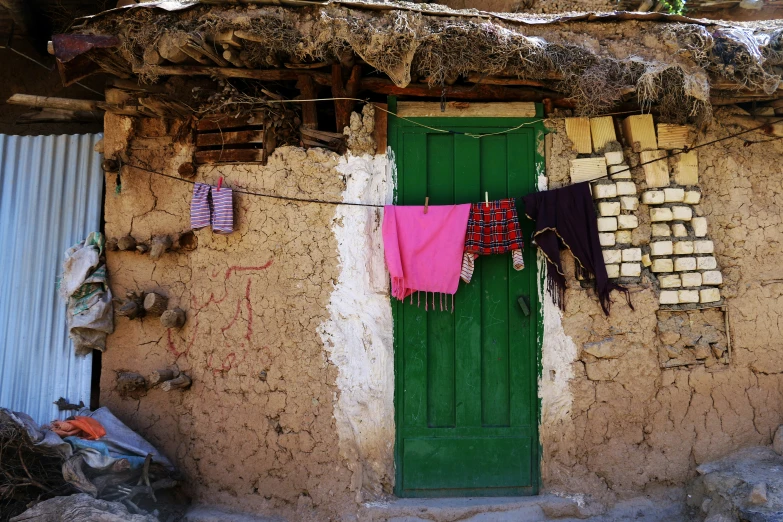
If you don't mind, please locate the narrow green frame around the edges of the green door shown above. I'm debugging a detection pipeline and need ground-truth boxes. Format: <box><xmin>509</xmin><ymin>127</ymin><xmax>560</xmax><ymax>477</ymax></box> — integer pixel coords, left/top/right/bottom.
<box><xmin>387</xmin><ymin>96</ymin><xmax>549</xmax><ymax>497</ymax></box>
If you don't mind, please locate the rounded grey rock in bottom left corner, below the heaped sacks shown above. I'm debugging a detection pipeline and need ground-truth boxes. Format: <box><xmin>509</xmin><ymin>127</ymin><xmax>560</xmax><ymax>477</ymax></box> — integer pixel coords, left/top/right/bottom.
<box><xmin>10</xmin><ymin>493</ymin><xmax>159</xmax><ymax>522</ymax></box>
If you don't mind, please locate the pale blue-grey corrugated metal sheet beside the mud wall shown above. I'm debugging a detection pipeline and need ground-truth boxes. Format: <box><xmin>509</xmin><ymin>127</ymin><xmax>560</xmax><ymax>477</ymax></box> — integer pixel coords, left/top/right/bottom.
<box><xmin>0</xmin><ymin>134</ymin><xmax>103</xmax><ymax>423</ymax></box>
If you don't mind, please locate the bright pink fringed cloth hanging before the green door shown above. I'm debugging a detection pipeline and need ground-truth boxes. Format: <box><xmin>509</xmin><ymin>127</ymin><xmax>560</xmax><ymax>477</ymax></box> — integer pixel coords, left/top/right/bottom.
<box><xmin>383</xmin><ymin>204</ymin><xmax>470</xmax><ymax>299</ymax></box>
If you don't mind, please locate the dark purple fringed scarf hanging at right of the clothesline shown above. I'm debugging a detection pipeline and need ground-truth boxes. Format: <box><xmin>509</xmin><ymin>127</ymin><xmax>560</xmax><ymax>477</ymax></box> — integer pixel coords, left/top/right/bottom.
<box><xmin>522</xmin><ymin>182</ymin><xmax>633</xmax><ymax>315</ymax></box>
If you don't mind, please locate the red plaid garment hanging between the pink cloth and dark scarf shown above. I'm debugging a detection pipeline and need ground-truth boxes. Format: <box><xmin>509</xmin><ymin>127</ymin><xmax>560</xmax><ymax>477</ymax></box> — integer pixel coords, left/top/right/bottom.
<box><xmin>465</xmin><ymin>199</ymin><xmax>525</xmax><ymax>255</ymax></box>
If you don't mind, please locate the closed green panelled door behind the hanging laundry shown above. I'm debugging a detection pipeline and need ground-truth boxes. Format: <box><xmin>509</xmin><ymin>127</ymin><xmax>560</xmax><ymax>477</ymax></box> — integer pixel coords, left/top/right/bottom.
<box><xmin>389</xmin><ymin>100</ymin><xmax>543</xmax><ymax>497</ymax></box>
